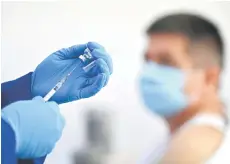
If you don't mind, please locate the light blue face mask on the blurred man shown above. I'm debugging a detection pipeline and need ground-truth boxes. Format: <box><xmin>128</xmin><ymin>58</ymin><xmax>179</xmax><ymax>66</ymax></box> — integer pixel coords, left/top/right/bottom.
<box><xmin>140</xmin><ymin>62</ymin><xmax>189</xmax><ymax>117</ymax></box>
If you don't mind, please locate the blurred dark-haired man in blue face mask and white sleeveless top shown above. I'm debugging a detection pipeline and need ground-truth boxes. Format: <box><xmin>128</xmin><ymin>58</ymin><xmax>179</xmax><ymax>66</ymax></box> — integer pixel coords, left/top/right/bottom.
<box><xmin>140</xmin><ymin>13</ymin><xmax>226</xmax><ymax>164</ymax></box>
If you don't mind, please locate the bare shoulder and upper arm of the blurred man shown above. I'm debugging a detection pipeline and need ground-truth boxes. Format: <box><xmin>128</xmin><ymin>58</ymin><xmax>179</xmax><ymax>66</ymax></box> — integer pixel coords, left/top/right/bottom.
<box><xmin>161</xmin><ymin>125</ymin><xmax>223</xmax><ymax>164</ymax></box>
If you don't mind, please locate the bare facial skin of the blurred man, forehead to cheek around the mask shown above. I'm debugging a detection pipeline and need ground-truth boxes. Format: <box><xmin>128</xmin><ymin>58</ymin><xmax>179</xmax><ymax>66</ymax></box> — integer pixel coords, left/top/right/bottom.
<box><xmin>145</xmin><ymin>33</ymin><xmax>216</xmax><ymax>111</ymax></box>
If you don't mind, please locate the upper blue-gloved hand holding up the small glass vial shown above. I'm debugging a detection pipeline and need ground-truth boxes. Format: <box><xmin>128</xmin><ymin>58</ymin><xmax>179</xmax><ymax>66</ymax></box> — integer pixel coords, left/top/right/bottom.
<box><xmin>31</xmin><ymin>42</ymin><xmax>113</xmax><ymax>103</ymax></box>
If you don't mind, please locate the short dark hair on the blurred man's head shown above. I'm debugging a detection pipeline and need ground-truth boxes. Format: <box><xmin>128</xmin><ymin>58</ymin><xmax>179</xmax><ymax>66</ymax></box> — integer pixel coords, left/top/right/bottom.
<box><xmin>147</xmin><ymin>13</ymin><xmax>224</xmax><ymax>67</ymax></box>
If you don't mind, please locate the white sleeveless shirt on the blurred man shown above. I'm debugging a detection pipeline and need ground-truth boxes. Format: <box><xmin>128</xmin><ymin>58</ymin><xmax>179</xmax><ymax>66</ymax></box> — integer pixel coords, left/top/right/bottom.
<box><xmin>138</xmin><ymin>114</ymin><xmax>230</xmax><ymax>164</ymax></box>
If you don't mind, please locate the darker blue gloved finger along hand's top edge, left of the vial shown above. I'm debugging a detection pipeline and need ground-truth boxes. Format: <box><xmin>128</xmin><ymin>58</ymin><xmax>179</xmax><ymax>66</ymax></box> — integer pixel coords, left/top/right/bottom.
<box><xmin>54</xmin><ymin>44</ymin><xmax>87</xmax><ymax>60</ymax></box>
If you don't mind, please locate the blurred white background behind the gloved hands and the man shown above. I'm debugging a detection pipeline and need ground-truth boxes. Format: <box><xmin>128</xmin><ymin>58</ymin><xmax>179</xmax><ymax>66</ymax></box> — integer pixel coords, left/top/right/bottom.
<box><xmin>1</xmin><ymin>0</ymin><xmax>230</xmax><ymax>164</ymax></box>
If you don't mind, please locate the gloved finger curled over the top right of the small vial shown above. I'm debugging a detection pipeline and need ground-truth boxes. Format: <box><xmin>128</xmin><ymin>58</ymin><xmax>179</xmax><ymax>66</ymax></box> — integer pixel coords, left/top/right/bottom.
<box><xmin>91</xmin><ymin>49</ymin><xmax>113</xmax><ymax>74</ymax></box>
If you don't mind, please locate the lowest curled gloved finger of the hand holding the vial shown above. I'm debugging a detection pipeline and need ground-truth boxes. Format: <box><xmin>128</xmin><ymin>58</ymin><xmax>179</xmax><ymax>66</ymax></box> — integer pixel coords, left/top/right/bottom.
<box><xmin>79</xmin><ymin>73</ymin><xmax>106</xmax><ymax>98</ymax></box>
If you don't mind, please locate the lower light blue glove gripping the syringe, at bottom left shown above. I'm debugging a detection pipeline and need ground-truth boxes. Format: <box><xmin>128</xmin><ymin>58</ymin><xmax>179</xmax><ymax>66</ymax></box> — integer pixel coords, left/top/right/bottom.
<box><xmin>2</xmin><ymin>97</ymin><xmax>65</xmax><ymax>159</ymax></box>
